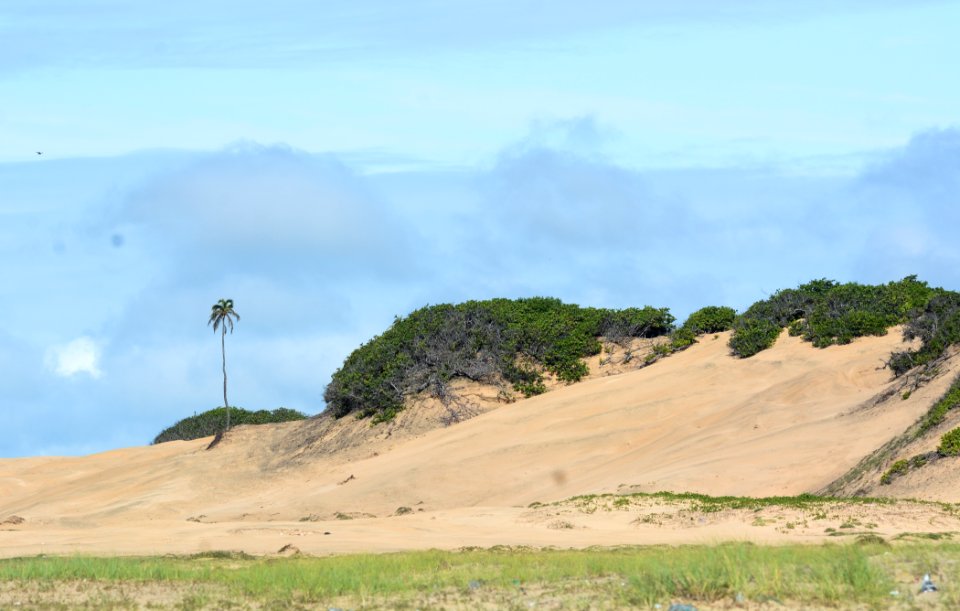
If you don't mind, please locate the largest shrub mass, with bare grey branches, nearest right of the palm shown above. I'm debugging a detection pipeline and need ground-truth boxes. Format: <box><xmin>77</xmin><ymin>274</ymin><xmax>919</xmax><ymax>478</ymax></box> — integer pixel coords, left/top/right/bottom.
<box><xmin>324</xmin><ymin>297</ymin><xmax>674</xmax><ymax>420</ymax></box>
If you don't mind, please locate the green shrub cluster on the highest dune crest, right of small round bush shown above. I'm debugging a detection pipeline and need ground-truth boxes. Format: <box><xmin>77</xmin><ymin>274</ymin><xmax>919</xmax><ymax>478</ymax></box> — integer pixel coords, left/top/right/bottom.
<box><xmin>730</xmin><ymin>276</ymin><xmax>943</xmax><ymax>358</ymax></box>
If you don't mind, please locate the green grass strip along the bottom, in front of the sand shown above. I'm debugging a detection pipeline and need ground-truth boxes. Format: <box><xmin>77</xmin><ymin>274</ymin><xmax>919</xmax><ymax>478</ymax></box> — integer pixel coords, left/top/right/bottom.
<box><xmin>0</xmin><ymin>539</ymin><xmax>960</xmax><ymax>608</ymax></box>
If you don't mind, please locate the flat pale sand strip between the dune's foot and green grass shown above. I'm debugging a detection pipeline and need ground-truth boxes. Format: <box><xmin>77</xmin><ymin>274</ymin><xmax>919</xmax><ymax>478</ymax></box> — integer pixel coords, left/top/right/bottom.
<box><xmin>2</xmin><ymin>496</ymin><xmax>960</xmax><ymax>556</ymax></box>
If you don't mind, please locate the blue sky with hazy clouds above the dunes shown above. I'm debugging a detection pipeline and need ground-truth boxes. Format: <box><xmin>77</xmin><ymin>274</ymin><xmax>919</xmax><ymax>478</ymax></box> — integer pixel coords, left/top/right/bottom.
<box><xmin>0</xmin><ymin>0</ymin><xmax>960</xmax><ymax>457</ymax></box>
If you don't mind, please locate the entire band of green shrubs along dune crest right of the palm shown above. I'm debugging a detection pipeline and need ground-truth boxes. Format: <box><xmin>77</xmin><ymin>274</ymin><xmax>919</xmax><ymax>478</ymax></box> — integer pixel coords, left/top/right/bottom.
<box><xmin>324</xmin><ymin>276</ymin><xmax>960</xmax><ymax>421</ymax></box>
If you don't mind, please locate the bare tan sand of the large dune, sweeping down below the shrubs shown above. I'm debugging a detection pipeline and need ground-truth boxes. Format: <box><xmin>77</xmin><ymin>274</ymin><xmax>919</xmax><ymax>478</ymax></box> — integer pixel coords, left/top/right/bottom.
<box><xmin>0</xmin><ymin>333</ymin><xmax>960</xmax><ymax>556</ymax></box>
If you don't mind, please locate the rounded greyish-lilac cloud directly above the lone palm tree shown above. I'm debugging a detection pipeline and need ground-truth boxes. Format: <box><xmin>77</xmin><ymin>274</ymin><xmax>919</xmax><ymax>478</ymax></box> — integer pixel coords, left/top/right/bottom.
<box><xmin>111</xmin><ymin>142</ymin><xmax>411</xmax><ymax>279</ymax></box>
